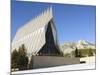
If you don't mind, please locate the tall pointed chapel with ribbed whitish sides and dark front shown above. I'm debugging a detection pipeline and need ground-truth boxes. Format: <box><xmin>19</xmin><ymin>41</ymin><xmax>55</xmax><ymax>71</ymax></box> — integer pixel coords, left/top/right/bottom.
<box><xmin>12</xmin><ymin>8</ymin><xmax>60</xmax><ymax>56</ymax></box>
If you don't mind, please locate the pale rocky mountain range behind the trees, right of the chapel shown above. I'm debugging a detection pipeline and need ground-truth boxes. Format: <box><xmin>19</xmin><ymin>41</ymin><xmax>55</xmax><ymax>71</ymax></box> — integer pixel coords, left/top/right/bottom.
<box><xmin>60</xmin><ymin>40</ymin><xmax>95</xmax><ymax>54</ymax></box>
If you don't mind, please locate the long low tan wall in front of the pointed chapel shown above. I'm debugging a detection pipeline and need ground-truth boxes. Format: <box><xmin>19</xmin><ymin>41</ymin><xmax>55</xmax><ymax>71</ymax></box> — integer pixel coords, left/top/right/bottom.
<box><xmin>33</xmin><ymin>56</ymin><xmax>80</xmax><ymax>69</ymax></box>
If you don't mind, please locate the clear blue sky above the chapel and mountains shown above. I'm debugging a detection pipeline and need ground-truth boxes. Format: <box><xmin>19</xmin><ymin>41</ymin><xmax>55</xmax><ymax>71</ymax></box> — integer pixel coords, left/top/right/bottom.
<box><xmin>11</xmin><ymin>1</ymin><xmax>96</xmax><ymax>43</ymax></box>
